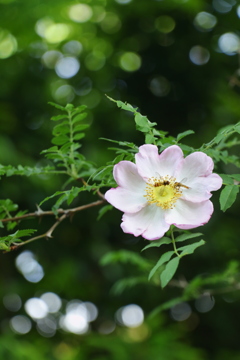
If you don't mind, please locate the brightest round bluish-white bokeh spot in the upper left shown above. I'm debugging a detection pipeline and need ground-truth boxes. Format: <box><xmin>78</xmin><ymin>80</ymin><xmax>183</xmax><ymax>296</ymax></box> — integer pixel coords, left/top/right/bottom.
<box><xmin>55</xmin><ymin>56</ymin><xmax>80</xmax><ymax>79</ymax></box>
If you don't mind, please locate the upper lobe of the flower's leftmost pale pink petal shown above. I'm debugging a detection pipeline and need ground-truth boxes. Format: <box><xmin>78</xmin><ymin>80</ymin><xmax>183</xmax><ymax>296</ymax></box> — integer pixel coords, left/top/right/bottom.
<box><xmin>113</xmin><ymin>161</ymin><xmax>146</xmax><ymax>194</ymax></box>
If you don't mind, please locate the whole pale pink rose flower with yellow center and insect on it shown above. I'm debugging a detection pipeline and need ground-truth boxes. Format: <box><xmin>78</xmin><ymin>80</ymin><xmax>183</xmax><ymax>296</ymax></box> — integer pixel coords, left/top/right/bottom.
<box><xmin>105</xmin><ymin>145</ymin><xmax>222</xmax><ymax>240</ymax></box>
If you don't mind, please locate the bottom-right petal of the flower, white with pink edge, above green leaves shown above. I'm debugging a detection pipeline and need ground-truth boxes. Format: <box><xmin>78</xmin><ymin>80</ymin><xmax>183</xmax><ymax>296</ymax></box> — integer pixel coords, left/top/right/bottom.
<box><xmin>165</xmin><ymin>199</ymin><xmax>213</xmax><ymax>227</ymax></box>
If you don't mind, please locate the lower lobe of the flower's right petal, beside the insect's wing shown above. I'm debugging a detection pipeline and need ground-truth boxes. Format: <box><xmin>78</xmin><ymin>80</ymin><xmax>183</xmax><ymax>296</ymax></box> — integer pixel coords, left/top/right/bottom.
<box><xmin>181</xmin><ymin>174</ymin><xmax>222</xmax><ymax>202</ymax></box>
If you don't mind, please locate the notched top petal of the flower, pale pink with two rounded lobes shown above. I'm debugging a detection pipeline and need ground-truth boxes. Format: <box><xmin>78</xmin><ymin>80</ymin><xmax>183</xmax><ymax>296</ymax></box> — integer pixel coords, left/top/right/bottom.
<box><xmin>135</xmin><ymin>145</ymin><xmax>183</xmax><ymax>180</ymax></box>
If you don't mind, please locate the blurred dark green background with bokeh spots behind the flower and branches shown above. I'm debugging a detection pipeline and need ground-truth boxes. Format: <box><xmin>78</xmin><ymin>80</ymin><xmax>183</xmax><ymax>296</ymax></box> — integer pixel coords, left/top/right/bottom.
<box><xmin>0</xmin><ymin>0</ymin><xmax>240</xmax><ymax>360</ymax></box>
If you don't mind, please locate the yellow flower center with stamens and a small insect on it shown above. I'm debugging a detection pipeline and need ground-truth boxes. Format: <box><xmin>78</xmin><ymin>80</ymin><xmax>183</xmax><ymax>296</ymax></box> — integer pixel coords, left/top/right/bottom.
<box><xmin>144</xmin><ymin>175</ymin><xmax>184</xmax><ymax>210</ymax></box>
